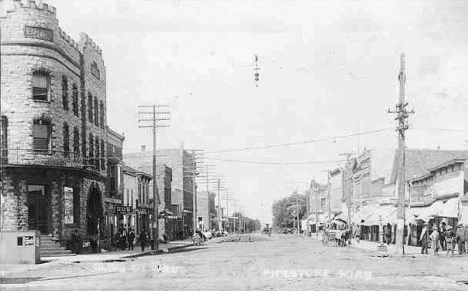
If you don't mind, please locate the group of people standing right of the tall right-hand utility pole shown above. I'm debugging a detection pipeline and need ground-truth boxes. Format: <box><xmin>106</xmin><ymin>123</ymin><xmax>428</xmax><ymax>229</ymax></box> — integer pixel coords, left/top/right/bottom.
<box><xmin>419</xmin><ymin>221</ymin><xmax>468</xmax><ymax>256</ymax></box>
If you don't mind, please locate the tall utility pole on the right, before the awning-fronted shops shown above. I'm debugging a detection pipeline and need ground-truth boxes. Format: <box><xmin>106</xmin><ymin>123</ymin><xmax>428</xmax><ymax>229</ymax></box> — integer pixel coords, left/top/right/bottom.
<box><xmin>388</xmin><ymin>53</ymin><xmax>414</xmax><ymax>255</ymax></box>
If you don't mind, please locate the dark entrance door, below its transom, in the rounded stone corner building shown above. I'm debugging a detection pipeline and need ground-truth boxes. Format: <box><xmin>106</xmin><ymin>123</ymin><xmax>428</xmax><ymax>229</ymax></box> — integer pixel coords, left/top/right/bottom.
<box><xmin>28</xmin><ymin>194</ymin><xmax>49</xmax><ymax>234</ymax></box>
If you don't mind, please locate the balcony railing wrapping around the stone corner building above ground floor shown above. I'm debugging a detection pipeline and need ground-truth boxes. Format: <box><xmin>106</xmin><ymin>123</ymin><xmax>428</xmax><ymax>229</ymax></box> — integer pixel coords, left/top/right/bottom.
<box><xmin>2</xmin><ymin>148</ymin><xmax>106</xmax><ymax>172</ymax></box>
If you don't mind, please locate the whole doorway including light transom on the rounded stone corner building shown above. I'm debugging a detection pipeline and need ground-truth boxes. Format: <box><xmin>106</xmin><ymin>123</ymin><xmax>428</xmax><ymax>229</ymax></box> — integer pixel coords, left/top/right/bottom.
<box><xmin>27</xmin><ymin>185</ymin><xmax>49</xmax><ymax>234</ymax></box>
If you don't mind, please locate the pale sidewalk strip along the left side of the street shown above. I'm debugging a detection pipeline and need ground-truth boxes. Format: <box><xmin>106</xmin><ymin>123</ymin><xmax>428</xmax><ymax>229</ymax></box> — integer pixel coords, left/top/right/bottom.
<box><xmin>41</xmin><ymin>239</ymin><xmax>192</xmax><ymax>262</ymax></box>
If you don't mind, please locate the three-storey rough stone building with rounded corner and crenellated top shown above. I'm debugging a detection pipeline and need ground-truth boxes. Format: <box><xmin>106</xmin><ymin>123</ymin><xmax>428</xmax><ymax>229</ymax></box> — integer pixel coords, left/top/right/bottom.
<box><xmin>0</xmin><ymin>1</ymin><xmax>107</xmax><ymax>246</ymax></box>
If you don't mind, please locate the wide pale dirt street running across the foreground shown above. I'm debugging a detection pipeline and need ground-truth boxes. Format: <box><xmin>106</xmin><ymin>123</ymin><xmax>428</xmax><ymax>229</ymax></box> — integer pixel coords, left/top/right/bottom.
<box><xmin>0</xmin><ymin>235</ymin><xmax>468</xmax><ymax>291</ymax></box>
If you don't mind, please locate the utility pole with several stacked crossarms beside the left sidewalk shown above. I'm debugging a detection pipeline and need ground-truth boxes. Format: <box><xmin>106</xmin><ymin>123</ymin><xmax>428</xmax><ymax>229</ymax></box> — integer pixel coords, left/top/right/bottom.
<box><xmin>138</xmin><ymin>104</ymin><xmax>170</xmax><ymax>252</ymax></box>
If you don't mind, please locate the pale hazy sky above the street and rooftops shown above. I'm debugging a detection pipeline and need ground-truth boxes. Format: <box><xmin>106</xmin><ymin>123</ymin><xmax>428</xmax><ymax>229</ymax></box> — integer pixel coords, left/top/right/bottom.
<box><xmin>11</xmin><ymin>0</ymin><xmax>468</xmax><ymax>222</ymax></box>
